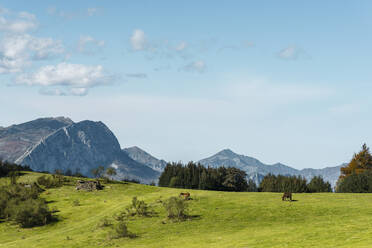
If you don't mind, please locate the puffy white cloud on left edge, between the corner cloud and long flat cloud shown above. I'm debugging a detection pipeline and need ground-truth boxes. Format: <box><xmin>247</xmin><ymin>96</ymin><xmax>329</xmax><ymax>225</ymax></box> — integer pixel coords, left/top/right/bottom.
<box><xmin>0</xmin><ymin>34</ymin><xmax>64</xmax><ymax>74</ymax></box>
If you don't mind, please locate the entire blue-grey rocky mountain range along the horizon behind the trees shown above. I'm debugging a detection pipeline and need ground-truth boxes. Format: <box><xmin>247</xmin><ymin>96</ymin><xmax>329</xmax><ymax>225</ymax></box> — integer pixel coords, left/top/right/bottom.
<box><xmin>0</xmin><ymin>117</ymin><xmax>343</xmax><ymax>186</ymax></box>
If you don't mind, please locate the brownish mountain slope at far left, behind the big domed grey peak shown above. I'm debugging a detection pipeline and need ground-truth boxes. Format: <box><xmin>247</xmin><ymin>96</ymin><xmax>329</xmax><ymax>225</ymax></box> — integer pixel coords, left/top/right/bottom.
<box><xmin>0</xmin><ymin>117</ymin><xmax>73</xmax><ymax>162</ymax></box>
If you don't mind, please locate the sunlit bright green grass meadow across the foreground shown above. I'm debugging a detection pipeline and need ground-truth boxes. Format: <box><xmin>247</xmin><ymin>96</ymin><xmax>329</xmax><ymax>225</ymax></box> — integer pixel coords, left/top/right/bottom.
<box><xmin>0</xmin><ymin>173</ymin><xmax>372</xmax><ymax>248</ymax></box>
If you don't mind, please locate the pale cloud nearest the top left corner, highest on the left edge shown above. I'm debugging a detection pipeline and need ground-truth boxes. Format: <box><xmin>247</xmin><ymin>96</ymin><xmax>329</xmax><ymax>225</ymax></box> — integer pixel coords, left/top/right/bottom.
<box><xmin>0</xmin><ymin>9</ymin><xmax>38</xmax><ymax>33</ymax></box>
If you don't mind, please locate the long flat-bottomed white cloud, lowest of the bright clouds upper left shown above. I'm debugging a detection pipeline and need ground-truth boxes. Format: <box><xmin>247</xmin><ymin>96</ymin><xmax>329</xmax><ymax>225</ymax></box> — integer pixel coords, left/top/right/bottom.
<box><xmin>16</xmin><ymin>63</ymin><xmax>112</xmax><ymax>88</ymax></box>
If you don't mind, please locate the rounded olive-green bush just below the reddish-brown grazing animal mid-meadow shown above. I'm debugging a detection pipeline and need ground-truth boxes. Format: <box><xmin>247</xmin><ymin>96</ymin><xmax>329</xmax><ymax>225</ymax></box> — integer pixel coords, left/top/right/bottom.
<box><xmin>163</xmin><ymin>196</ymin><xmax>188</xmax><ymax>221</ymax></box>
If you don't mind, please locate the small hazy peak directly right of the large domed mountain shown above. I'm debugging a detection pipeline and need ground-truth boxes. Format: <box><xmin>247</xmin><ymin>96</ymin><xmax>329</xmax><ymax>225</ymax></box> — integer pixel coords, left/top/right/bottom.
<box><xmin>123</xmin><ymin>146</ymin><xmax>167</xmax><ymax>172</ymax></box>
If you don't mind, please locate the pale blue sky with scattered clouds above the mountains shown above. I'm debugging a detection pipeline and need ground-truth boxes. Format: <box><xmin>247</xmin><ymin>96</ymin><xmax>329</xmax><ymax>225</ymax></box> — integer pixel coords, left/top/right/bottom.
<box><xmin>0</xmin><ymin>0</ymin><xmax>372</xmax><ymax>169</ymax></box>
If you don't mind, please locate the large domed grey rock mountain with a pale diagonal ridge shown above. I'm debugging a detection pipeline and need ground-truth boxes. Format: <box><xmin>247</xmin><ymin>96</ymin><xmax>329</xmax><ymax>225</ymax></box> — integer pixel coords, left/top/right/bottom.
<box><xmin>15</xmin><ymin>121</ymin><xmax>159</xmax><ymax>183</ymax></box>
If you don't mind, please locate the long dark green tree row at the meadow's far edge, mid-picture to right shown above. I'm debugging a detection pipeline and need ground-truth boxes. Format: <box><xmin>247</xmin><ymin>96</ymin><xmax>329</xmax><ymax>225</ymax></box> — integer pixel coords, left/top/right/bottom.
<box><xmin>159</xmin><ymin>162</ymin><xmax>332</xmax><ymax>193</ymax></box>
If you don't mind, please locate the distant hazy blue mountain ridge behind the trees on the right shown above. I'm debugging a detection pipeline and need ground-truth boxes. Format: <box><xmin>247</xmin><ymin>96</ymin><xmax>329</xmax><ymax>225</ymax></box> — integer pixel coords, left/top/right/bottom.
<box><xmin>199</xmin><ymin>149</ymin><xmax>341</xmax><ymax>187</ymax></box>
